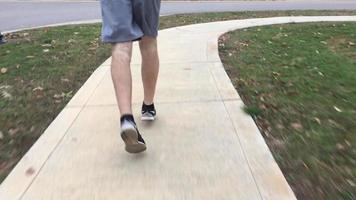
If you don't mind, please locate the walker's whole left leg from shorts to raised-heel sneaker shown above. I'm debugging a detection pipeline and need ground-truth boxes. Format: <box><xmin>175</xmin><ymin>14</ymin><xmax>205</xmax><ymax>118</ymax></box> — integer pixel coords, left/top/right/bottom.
<box><xmin>100</xmin><ymin>0</ymin><xmax>146</xmax><ymax>153</ymax></box>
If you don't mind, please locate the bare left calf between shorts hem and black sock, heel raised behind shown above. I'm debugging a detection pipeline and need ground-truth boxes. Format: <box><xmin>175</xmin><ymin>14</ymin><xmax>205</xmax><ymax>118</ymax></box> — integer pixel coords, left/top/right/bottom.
<box><xmin>111</xmin><ymin>42</ymin><xmax>132</xmax><ymax>116</ymax></box>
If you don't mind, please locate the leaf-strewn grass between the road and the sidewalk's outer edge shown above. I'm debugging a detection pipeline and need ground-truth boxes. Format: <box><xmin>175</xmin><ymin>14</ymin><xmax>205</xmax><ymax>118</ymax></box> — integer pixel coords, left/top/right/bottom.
<box><xmin>0</xmin><ymin>8</ymin><xmax>356</xmax><ymax>197</ymax></box>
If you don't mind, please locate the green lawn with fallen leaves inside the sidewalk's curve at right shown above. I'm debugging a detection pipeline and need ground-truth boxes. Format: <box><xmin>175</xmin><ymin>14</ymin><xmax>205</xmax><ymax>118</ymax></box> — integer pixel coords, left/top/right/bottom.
<box><xmin>219</xmin><ymin>23</ymin><xmax>356</xmax><ymax>200</ymax></box>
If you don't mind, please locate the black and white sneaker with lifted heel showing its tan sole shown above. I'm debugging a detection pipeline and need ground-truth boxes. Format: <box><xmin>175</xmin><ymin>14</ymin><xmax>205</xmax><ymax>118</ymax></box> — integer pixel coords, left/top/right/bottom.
<box><xmin>120</xmin><ymin>115</ymin><xmax>146</xmax><ymax>153</ymax></box>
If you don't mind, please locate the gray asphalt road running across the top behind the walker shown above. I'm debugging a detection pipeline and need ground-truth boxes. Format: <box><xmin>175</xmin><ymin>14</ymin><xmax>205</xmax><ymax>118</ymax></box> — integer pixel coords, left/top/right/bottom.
<box><xmin>0</xmin><ymin>0</ymin><xmax>356</xmax><ymax>31</ymax></box>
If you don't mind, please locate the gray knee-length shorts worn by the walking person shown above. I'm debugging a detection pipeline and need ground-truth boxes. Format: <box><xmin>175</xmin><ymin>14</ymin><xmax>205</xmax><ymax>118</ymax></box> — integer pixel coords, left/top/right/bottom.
<box><xmin>100</xmin><ymin>0</ymin><xmax>161</xmax><ymax>43</ymax></box>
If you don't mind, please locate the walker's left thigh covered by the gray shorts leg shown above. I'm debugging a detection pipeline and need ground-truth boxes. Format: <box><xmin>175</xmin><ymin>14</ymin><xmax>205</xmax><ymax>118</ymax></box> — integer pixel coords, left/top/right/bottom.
<box><xmin>100</xmin><ymin>0</ymin><xmax>143</xmax><ymax>43</ymax></box>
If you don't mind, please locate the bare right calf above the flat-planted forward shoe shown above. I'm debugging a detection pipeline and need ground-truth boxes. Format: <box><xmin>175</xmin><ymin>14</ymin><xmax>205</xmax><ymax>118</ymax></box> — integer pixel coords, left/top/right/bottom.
<box><xmin>139</xmin><ymin>36</ymin><xmax>159</xmax><ymax>105</ymax></box>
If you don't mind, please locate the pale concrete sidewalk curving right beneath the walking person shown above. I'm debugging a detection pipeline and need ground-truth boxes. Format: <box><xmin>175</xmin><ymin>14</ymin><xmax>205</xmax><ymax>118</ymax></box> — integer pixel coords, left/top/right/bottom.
<box><xmin>0</xmin><ymin>16</ymin><xmax>356</xmax><ymax>200</ymax></box>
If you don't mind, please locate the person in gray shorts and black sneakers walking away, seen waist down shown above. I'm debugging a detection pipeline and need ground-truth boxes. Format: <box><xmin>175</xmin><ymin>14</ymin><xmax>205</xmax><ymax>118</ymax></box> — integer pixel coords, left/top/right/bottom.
<box><xmin>100</xmin><ymin>0</ymin><xmax>161</xmax><ymax>153</ymax></box>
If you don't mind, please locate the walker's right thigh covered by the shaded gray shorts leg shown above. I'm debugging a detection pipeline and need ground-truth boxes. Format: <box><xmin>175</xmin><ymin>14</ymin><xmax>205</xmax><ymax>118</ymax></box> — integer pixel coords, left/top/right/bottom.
<box><xmin>132</xmin><ymin>0</ymin><xmax>161</xmax><ymax>37</ymax></box>
